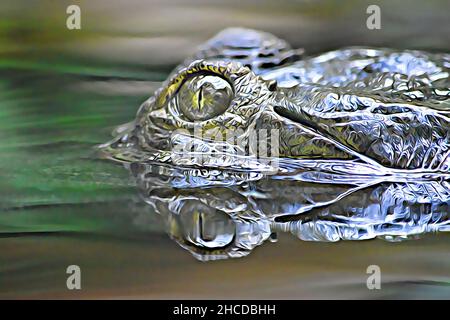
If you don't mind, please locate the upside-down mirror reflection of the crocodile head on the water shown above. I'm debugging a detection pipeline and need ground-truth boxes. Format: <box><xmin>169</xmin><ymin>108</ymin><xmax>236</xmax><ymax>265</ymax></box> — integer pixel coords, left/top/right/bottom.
<box><xmin>130</xmin><ymin>163</ymin><xmax>450</xmax><ymax>261</ymax></box>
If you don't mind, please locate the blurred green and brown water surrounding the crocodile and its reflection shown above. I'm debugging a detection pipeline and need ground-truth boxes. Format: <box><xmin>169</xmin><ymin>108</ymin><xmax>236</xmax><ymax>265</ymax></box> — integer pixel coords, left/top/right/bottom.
<box><xmin>0</xmin><ymin>1</ymin><xmax>450</xmax><ymax>299</ymax></box>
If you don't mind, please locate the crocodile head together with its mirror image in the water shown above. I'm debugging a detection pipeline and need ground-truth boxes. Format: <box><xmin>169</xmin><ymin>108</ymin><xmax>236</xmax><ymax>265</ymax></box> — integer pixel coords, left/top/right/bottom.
<box><xmin>100</xmin><ymin>28</ymin><xmax>450</xmax><ymax>261</ymax></box>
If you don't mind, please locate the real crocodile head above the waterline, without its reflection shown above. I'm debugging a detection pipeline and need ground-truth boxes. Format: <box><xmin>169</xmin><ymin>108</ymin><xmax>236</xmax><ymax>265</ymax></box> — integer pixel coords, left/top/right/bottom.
<box><xmin>103</xmin><ymin>29</ymin><xmax>450</xmax><ymax>173</ymax></box>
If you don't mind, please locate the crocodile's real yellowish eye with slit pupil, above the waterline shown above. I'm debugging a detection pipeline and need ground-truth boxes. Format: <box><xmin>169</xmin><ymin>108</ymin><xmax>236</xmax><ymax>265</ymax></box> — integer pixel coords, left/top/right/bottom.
<box><xmin>177</xmin><ymin>75</ymin><xmax>233</xmax><ymax>121</ymax></box>
